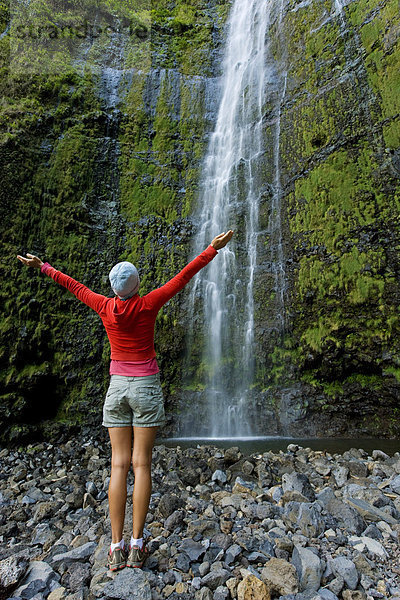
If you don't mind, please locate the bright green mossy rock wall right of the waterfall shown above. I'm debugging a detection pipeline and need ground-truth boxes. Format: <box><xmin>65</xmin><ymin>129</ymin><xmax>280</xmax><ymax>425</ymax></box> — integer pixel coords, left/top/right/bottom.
<box><xmin>274</xmin><ymin>0</ymin><xmax>400</xmax><ymax>435</ymax></box>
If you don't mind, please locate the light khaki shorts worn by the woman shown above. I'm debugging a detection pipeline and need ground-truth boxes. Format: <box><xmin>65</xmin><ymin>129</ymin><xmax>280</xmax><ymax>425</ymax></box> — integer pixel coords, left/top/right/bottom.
<box><xmin>103</xmin><ymin>373</ymin><xmax>165</xmax><ymax>427</ymax></box>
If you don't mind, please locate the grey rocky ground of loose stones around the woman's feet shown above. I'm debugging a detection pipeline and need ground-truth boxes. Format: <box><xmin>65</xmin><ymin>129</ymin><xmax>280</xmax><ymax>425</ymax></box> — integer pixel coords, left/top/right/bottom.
<box><xmin>0</xmin><ymin>439</ymin><xmax>400</xmax><ymax>600</ymax></box>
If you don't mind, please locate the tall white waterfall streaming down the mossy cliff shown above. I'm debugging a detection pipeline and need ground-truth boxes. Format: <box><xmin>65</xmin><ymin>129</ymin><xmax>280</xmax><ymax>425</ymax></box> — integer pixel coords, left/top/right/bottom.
<box><xmin>186</xmin><ymin>0</ymin><xmax>285</xmax><ymax>437</ymax></box>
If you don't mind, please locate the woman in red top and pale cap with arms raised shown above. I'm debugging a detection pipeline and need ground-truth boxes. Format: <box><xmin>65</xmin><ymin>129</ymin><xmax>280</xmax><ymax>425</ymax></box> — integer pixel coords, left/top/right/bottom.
<box><xmin>17</xmin><ymin>230</ymin><xmax>233</xmax><ymax>571</ymax></box>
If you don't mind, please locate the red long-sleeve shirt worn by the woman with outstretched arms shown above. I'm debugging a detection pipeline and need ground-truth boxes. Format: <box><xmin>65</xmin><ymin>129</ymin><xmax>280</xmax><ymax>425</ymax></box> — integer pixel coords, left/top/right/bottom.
<box><xmin>41</xmin><ymin>244</ymin><xmax>218</xmax><ymax>361</ymax></box>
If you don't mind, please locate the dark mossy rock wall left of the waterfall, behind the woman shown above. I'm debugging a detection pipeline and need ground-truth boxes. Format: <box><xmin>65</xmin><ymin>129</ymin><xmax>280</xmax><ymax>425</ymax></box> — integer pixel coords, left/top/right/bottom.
<box><xmin>0</xmin><ymin>0</ymin><xmax>227</xmax><ymax>442</ymax></box>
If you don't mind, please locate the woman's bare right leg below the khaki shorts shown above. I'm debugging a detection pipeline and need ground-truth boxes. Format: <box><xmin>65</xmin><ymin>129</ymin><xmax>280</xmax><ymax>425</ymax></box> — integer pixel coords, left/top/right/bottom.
<box><xmin>132</xmin><ymin>427</ymin><xmax>158</xmax><ymax>539</ymax></box>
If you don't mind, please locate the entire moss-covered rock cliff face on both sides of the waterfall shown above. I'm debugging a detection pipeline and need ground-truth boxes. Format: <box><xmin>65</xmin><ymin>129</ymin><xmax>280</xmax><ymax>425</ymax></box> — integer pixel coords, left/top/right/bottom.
<box><xmin>0</xmin><ymin>0</ymin><xmax>400</xmax><ymax>441</ymax></box>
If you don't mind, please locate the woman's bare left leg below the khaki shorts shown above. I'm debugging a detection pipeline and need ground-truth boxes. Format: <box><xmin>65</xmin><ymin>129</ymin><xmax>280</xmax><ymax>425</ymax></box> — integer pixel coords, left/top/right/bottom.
<box><xmin>108</xmin><ymin>427</ymin><xmax>132</xmax><ymax>544</ymax></box>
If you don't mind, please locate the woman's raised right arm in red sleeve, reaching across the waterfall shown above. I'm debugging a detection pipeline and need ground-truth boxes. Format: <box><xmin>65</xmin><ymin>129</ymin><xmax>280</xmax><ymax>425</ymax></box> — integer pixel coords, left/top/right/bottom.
<box><xmin>144</xmin><ymin>230</ymin><xmax>233</xmax><ymax>311</ymax></box>
